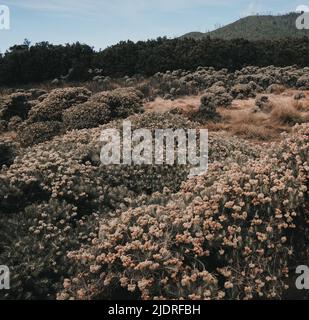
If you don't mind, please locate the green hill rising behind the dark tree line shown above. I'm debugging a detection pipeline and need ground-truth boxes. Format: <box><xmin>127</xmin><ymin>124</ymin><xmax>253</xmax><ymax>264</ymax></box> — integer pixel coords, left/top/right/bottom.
<box><xmin>182</xmin><ymin>13</ymin><xmax>309</xmax><ymax>41</ymax></box>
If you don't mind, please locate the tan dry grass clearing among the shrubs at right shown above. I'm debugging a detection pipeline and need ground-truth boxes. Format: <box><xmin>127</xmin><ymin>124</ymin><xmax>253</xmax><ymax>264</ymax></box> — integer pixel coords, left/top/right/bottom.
<box><xmin>145</xmin><ymin>92</ymin><xmax>309</xmax><ymax>141</ymax></box>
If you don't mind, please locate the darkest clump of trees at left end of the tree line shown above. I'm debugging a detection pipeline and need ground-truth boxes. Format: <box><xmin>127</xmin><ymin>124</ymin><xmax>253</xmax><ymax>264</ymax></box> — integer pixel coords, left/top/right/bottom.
<box><xmin>0</xmin><ymin>42</ymin><xmax>95</xmax><ymax>85</ymax></box>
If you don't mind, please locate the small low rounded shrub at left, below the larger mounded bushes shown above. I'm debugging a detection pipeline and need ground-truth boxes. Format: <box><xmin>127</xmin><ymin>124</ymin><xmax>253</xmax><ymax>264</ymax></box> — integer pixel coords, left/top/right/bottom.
<box><xmin>17</xmin><ymin>121</ymin><xmax>62</xmax><ymax>147</ymax></box>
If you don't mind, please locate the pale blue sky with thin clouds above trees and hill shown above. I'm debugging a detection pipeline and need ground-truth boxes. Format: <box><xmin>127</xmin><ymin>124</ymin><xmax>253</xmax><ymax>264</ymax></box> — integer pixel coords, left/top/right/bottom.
<box><xmin>0</xmin><ymin>0</ymin><xmax>309</xmax><ymax>53</ymax></box>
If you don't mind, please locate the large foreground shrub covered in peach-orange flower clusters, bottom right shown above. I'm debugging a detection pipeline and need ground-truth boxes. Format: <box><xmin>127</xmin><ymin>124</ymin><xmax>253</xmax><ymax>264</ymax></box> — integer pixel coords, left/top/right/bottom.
<box><xmin>58</xmin><ymin>125</ymin><xmax>309</xmax><ymax>299</ymax></box>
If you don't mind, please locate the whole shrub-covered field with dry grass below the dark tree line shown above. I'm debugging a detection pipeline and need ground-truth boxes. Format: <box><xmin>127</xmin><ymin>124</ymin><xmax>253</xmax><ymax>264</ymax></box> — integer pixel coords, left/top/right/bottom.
<box><xmin>0</xmin><ymin>66</ymin><xmax>309</xmax><ymax>300</ymax></box>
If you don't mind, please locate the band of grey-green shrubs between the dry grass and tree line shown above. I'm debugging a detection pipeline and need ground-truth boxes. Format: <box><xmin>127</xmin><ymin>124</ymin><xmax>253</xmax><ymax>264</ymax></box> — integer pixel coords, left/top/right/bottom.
<box><xmin>143</xmin><ymin>66</ymin><xmax>308</xmax><ymax>99</ymax></box>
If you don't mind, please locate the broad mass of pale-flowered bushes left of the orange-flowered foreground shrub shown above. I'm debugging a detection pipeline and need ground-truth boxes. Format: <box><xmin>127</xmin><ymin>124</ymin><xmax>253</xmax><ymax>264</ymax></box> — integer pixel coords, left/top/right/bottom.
<box><xmin>0</xmin><ymin>109</ymin><xmax>266</xmax><ymax>299</ymax></box>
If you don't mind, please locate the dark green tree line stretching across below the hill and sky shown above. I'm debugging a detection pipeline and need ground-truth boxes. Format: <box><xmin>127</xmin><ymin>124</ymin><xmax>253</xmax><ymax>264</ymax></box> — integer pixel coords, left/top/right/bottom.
<box><xmin>0</xmin><ymin>37</ymin><xmax>309</xmax><ymax>86</ymax></box>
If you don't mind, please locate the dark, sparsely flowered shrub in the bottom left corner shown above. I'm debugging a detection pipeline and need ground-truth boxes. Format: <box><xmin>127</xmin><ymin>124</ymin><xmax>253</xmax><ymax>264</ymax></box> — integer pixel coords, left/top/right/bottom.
<box><xmin>0</xmin><ymin>200</ymin><xmax>98</xmax><ymax>299</ymax></box>
